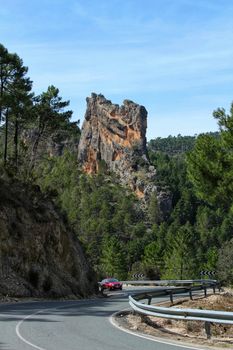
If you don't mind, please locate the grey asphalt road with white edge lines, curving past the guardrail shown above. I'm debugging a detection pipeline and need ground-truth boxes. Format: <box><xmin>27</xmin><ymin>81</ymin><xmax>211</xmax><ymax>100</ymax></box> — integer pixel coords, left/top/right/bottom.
<box><xmin>0</xmin><ymin>290</ymin><xmax>208</xmax><ymax>350</ymax></box>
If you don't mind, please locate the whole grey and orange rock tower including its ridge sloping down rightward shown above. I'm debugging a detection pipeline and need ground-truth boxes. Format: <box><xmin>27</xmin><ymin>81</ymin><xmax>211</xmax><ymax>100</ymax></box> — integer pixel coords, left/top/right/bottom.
<box><xmin>78</xmin><ymin>93</ymin><xmax>171</xmax><ymax>216</ymax></box>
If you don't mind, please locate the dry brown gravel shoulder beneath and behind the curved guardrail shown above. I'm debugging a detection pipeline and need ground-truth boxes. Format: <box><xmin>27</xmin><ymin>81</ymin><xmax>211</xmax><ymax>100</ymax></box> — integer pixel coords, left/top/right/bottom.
<box><xmin>115</xmin><ymin>290</ymin><xmax>233</xmax><ymax>349</ymax></box>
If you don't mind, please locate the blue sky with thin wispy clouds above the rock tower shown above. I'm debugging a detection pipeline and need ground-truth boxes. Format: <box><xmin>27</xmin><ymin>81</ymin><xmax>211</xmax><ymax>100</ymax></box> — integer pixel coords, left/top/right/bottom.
<box><xmin>0</xmin><ymin>0</ymin><xmax>233</xmax><ymax>140</ymax></box>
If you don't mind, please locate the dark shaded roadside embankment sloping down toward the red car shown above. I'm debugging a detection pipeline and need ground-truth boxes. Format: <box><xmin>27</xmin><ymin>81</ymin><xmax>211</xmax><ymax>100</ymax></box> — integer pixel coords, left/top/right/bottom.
<box><xmin>0</xmin><ymin>175</ymin><xmax>97</xmax><ymax>297</ymax></box>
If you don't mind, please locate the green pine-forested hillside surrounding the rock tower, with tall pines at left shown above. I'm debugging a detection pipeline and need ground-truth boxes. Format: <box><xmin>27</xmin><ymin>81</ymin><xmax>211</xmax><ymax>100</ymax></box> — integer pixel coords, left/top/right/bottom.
<box><xmin>0</xmin><ymin>46</ymin><xmax>233</xmax><ymax>283</ymax></box>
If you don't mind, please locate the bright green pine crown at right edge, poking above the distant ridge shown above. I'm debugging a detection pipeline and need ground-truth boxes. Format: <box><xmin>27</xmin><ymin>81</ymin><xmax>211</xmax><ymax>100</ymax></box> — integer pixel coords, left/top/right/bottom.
<box><xmin>187</xmin><ymin>104</ymin><xmax>233</xmax><ymax>210</ymax></box>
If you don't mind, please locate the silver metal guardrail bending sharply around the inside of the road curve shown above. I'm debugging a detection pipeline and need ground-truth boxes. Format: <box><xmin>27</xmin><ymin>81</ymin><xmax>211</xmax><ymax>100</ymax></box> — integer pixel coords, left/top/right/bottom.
<box><xmin>129</xmin><ymin>280</ymin><xmax>233</xmax><ymax>338</ymax></box>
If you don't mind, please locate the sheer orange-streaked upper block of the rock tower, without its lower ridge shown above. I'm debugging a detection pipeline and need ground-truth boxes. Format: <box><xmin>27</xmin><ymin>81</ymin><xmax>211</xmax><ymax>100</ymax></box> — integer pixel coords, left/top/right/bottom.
<box><xmin>78</xmin><ymin>93</ymin><xmax>147</xmax><ymax>174</ymax></box>
